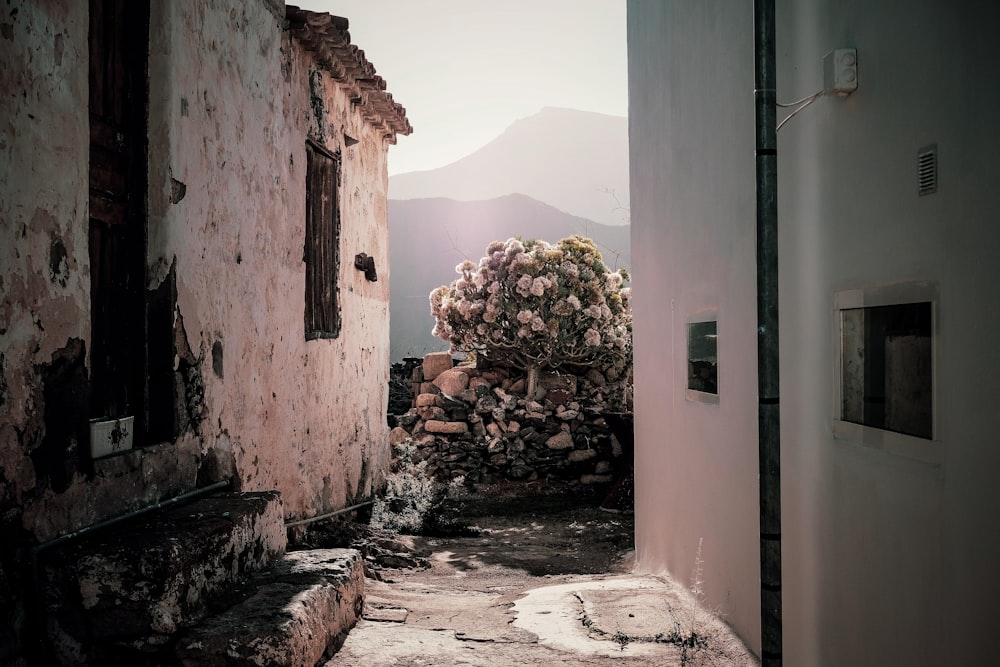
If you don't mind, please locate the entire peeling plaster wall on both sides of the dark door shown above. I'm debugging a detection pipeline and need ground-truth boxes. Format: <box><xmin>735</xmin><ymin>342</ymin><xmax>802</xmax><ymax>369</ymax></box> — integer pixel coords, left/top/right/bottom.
<box><xmin>0</xmin><ymin>0</ymin><xmax>389</xmax><ymax>548</ymax></box>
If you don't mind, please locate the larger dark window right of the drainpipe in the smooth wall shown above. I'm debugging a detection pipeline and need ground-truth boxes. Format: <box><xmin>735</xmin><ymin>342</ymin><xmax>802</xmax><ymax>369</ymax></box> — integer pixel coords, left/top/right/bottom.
<box><xmin>840</xmin><ymin>301</ymin><xmax>934</xmax><ymax>439</ymax></box>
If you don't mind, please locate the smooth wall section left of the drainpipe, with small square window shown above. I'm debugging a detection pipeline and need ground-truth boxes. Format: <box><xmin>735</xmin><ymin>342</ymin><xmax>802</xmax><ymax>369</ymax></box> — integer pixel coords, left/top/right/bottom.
<box><xmin>628</xmin><ymin>2</ymin><xmax>759</xmax><ymax>644</ymax></box>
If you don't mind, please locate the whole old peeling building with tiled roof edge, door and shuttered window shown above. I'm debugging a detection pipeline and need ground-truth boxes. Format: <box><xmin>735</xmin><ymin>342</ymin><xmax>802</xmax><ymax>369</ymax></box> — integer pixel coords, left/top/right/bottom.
<box><xmin>0</xmin><ymin>0</ymin><xmax>411</xmax><ymax>664</ymax></box>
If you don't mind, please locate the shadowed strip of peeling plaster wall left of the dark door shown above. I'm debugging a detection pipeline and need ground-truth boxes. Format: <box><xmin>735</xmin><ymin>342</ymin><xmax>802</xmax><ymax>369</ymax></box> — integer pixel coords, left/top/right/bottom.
<box><xmin>0</xmin><ymin>0</ymin><xmax>90</xmax><ymax>530</ymax></box>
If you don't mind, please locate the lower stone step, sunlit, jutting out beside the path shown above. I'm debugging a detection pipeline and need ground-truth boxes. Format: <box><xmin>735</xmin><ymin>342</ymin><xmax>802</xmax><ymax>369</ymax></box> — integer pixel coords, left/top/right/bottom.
<box><xmin>176</xmin><ymin>549</ymin><xmax>365</xmax><ymax>667</ymax></box>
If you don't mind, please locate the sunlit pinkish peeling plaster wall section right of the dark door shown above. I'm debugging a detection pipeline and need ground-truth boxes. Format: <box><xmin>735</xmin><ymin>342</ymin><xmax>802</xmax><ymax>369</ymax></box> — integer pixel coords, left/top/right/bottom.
<box><xmin>149</xmin><ymin>0</ymin><xmax>389</xmax><ymax>517</ymax></box>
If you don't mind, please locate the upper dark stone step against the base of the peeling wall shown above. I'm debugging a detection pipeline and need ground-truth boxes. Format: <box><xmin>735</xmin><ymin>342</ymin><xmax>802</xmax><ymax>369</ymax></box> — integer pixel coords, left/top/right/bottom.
<box><xmin>39</xmin><ymin>491</ymin><xmax>287</xmax><ymax>664</ymax></box>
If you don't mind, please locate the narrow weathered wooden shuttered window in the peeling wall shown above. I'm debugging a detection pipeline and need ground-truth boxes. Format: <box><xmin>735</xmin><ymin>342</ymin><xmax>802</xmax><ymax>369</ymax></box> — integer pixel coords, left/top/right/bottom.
<box><xmin>305</xmin><ymin>141</ymin><xmax>340</xmax><ymax>340</ymax></box>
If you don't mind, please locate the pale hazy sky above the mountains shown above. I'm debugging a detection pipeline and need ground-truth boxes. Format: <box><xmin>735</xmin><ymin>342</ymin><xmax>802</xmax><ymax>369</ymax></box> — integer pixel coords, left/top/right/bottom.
<box><xmin>289</xmin><ymin>0</ymin><xmax>628</xmax><ymax>174</ymax></box>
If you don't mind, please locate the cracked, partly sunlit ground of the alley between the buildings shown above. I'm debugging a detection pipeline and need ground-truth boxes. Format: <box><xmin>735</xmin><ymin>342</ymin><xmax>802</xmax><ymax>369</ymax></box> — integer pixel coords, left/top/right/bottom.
<box><xmin>306</xmin><ymin>485</ymin><xmax>757</xmax><ymax>667</ymax></box>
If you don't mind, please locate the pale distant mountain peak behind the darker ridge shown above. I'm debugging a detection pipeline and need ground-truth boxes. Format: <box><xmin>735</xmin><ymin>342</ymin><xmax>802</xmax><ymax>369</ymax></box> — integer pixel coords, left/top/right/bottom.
<box><xmin>389</xmin><ymin>107</ymin><xmax>629</xmax><ymax>225</ymax></box>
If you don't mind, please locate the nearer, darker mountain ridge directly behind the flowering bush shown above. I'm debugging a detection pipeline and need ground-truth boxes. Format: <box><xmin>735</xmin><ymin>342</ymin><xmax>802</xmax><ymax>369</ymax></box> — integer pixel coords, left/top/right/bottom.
<box><xmin>389</xmin><ymin>194</ymin><xmax>631</xmax><ymax>361</ymax></box>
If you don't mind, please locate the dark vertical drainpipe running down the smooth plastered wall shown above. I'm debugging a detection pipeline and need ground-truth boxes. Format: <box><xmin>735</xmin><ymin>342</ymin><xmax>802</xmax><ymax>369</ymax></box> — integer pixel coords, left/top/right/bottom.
<box><xmin>753</xmin><ymin>0</ymin><xmax>781</xmax><ymax>667</ymax></box>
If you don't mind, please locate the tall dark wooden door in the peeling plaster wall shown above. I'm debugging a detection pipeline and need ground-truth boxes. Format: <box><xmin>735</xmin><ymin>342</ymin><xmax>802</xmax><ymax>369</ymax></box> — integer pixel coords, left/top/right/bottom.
<box><xmin>89</xmin><ymin>0</ymin><xmax>149</xmax><ymax>428</ymax></box>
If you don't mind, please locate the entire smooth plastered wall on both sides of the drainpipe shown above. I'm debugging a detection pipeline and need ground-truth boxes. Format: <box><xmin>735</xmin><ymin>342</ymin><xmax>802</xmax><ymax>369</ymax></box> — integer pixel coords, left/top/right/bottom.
<box><xmin>629</xmin><ymin>0</ymin><xmax>1000</xmax><ymax>666</ymax></box>
